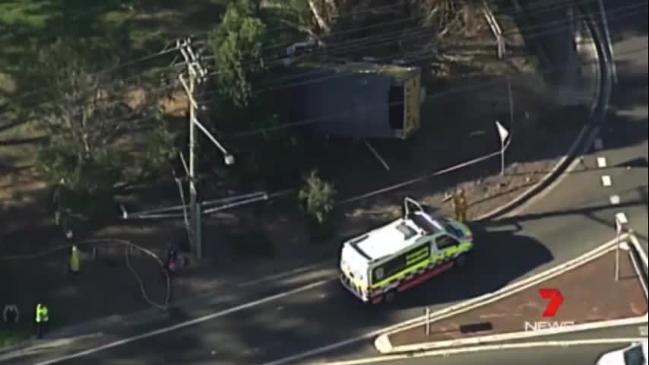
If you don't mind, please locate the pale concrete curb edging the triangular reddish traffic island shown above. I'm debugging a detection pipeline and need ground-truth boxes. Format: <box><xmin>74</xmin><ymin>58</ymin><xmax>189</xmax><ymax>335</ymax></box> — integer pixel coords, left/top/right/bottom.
<box><xmin>374</xmin><ymin>235</ymin><xmax>649</xmax><ymax>354</ymax></box>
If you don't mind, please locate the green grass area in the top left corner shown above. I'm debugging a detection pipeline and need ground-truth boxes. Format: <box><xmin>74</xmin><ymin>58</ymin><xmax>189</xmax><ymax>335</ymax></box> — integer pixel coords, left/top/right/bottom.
<box><xmin>0</xmin><ymin>0</ymin><xmax>227</xmax><ymax>100</ymax></box>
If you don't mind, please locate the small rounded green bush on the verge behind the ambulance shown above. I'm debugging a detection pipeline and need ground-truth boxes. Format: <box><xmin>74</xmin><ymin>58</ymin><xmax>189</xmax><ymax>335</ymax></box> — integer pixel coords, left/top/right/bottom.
<box><xmin>298</xmin><ymin>170</ymin><xmax>336</xmax><ymax>229</ymax></box>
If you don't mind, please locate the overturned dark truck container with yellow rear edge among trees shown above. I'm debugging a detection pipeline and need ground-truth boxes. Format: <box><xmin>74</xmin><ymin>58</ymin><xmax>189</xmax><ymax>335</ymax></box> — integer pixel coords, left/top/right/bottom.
<box><xmin>291</xmin><ymin>62</ymin><xmax>421</xmax><ymax>139</ymax></box>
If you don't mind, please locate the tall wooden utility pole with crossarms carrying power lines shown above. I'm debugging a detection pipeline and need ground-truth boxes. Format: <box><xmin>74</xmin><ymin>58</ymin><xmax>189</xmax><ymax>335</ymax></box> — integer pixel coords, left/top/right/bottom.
<box><xmin>178</xmin><ymin>39</ymin><xmax>207</xmax><ymax>259</ymax></box>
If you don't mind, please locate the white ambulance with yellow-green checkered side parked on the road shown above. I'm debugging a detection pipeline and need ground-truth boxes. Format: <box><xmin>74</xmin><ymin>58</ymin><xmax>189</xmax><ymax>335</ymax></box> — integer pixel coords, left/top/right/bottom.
<box><xmin>340</xmin><ymin>197</ymin><xmax>473</xmax><ymax>304</ymax></box>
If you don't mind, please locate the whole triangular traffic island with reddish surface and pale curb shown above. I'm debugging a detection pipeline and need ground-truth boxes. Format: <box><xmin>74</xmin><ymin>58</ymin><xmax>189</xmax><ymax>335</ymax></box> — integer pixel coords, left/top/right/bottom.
<box><xmin>374</xmin><ymin>236</ymin><xmax>648</xmax><ymax>354</ymax></box>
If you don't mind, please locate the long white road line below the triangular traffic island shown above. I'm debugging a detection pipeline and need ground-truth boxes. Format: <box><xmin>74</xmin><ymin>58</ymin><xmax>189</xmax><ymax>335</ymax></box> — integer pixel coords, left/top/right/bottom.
<box><xmin>312</xmin><ymin>337</ymin><xmax>645</xmax><ymax>365</ymax></box>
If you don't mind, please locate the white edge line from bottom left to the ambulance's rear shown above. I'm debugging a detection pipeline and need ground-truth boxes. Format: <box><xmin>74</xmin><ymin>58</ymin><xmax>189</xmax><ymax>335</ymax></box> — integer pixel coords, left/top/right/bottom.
<box><xmin>35</xmin><ymin>280</ymin><xmax>330</xmax><ymax>365</ymax></box>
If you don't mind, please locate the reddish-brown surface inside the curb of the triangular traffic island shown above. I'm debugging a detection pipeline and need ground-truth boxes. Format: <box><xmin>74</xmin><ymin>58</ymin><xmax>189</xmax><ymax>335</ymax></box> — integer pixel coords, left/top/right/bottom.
<box><xmin>389</xmin><ymin>247</ymin><xmax>647</xmax><ymax>347</ymax></box>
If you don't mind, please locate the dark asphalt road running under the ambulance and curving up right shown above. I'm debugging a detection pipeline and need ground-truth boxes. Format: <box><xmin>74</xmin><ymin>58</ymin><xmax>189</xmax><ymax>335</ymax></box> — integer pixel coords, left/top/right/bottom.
<box><xmin>2</xmin><ymin>0</ymin><xmax>648</xmax><ymax>365</ymax></box>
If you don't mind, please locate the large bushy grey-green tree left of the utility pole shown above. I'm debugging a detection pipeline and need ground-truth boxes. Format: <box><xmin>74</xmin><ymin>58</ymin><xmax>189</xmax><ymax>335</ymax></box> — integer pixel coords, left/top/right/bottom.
<box><xmin>30</xmin><ymin>41</ymin><xmax>173</xmax><ymax>232</ymax></box>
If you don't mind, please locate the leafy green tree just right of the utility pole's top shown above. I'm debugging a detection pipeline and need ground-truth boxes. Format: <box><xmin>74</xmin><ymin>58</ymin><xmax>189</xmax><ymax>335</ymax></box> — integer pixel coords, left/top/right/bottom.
<box><xmin>208</xmin><ymin>0</ymin><xmax>266</xmax><ymax>107</ymax></box>
